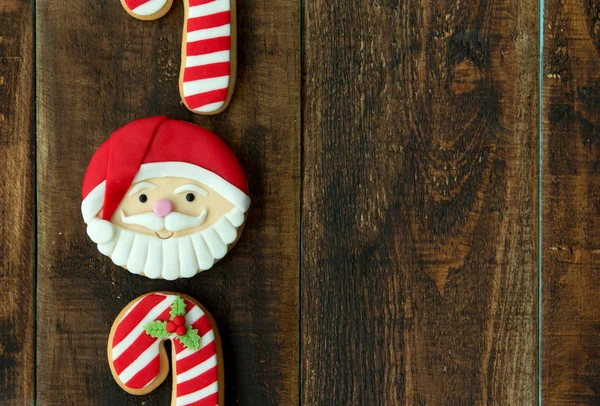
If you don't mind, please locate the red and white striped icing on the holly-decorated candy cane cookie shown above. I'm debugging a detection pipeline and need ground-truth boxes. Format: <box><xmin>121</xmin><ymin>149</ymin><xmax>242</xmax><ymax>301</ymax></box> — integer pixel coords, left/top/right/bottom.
<box><xmin>110</xmin><ymin>293</ymin><xmax>219</xmax><ymax>406</ymax></box>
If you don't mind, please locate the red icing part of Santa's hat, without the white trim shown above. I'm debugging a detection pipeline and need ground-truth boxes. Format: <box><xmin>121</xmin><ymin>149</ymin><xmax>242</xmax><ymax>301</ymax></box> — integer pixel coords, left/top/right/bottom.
<box><xmin>82</xmin><ymin>117</ymin><xmax>248</xmax><ymax>220</ymax></box>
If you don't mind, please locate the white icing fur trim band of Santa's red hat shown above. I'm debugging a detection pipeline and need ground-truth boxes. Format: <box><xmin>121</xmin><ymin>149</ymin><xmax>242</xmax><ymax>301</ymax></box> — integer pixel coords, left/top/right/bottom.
<box><xmin>81</xmin><ymin>162</ymin><xmax>250</xmax><ymax>223</ymax></box>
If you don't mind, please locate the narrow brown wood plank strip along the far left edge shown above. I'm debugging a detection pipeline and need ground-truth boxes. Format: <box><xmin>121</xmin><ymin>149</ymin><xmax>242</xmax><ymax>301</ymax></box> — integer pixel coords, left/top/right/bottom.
<box><xmin>0</xmin><ymin>0</ymin><xmax>35</xmax><ymax>405</ymax></box>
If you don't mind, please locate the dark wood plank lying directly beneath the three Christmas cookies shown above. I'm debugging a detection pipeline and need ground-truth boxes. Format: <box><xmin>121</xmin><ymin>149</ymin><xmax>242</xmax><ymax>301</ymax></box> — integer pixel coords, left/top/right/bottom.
<box><xmin>37</xmin><ymin>0</ymin><xmax>300</xmax><ymax>405</ymax></box>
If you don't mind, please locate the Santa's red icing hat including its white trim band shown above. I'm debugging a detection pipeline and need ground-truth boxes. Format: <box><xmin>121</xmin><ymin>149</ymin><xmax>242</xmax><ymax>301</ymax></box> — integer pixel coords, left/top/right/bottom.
<box><xmin>81</xmin><ymin>117</ymin><xmax>250</xmax><ymax>223</ymax></box>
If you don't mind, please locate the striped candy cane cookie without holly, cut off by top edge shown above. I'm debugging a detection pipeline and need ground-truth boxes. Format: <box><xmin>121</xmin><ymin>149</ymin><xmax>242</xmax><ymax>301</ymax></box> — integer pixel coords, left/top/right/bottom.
<box><xmin>121</xmin><ymin>0</ymin><xmax>236</xmax><ymax>115</ymax></box>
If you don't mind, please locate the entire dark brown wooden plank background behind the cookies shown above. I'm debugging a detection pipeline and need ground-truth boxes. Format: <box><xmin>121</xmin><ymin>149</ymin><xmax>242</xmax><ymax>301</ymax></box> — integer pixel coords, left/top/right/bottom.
<box><xmin>0</xmin><ymin>0</ymin><xmax>600</xmax><ymax>406</ymax></box>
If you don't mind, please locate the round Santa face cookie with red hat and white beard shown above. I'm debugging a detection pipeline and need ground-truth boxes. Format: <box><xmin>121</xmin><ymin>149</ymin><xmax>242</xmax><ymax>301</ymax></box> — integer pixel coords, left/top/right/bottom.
<box><xmin>81</xmin><ymin>117</ymin><xmax>250</xmax><ymax>280</ymax></box>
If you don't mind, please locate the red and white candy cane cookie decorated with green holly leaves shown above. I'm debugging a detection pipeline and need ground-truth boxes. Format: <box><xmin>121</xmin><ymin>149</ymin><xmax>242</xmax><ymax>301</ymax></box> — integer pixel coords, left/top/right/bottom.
<box><xmin>108</xmin><ymin>292</ymin><xmax>224</xmax><ymax>406</ymax></box>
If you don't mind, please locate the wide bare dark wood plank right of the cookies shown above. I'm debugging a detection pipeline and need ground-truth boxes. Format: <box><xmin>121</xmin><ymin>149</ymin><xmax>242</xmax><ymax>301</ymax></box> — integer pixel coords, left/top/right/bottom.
<box><xmin>301</xmin><ymin>0</ymin><xmax>538</xmax><ymax>405</ymax></box>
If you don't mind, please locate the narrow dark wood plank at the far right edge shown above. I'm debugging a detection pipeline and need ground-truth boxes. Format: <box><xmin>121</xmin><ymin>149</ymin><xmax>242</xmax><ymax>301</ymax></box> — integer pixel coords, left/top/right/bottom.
<box><xmin>542</xmin><ymin>0</ymin><xmax>600</xmax><ymax>405</ymax></box>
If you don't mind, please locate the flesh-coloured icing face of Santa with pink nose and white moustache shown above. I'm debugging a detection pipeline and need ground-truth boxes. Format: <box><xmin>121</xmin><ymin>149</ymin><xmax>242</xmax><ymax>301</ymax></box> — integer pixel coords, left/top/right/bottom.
<box><xmin>110</xmin><ymin>177</ymin><xmax>234</xmax><ymax>239</ymax></box>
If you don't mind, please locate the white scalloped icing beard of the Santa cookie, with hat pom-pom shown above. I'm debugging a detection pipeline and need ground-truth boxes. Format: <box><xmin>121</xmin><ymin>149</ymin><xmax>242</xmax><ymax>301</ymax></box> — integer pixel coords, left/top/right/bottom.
<box><xmin>87</xmin><ymin>207</ymin><xmax>244</xmax><ymax>280</ymax></box>
